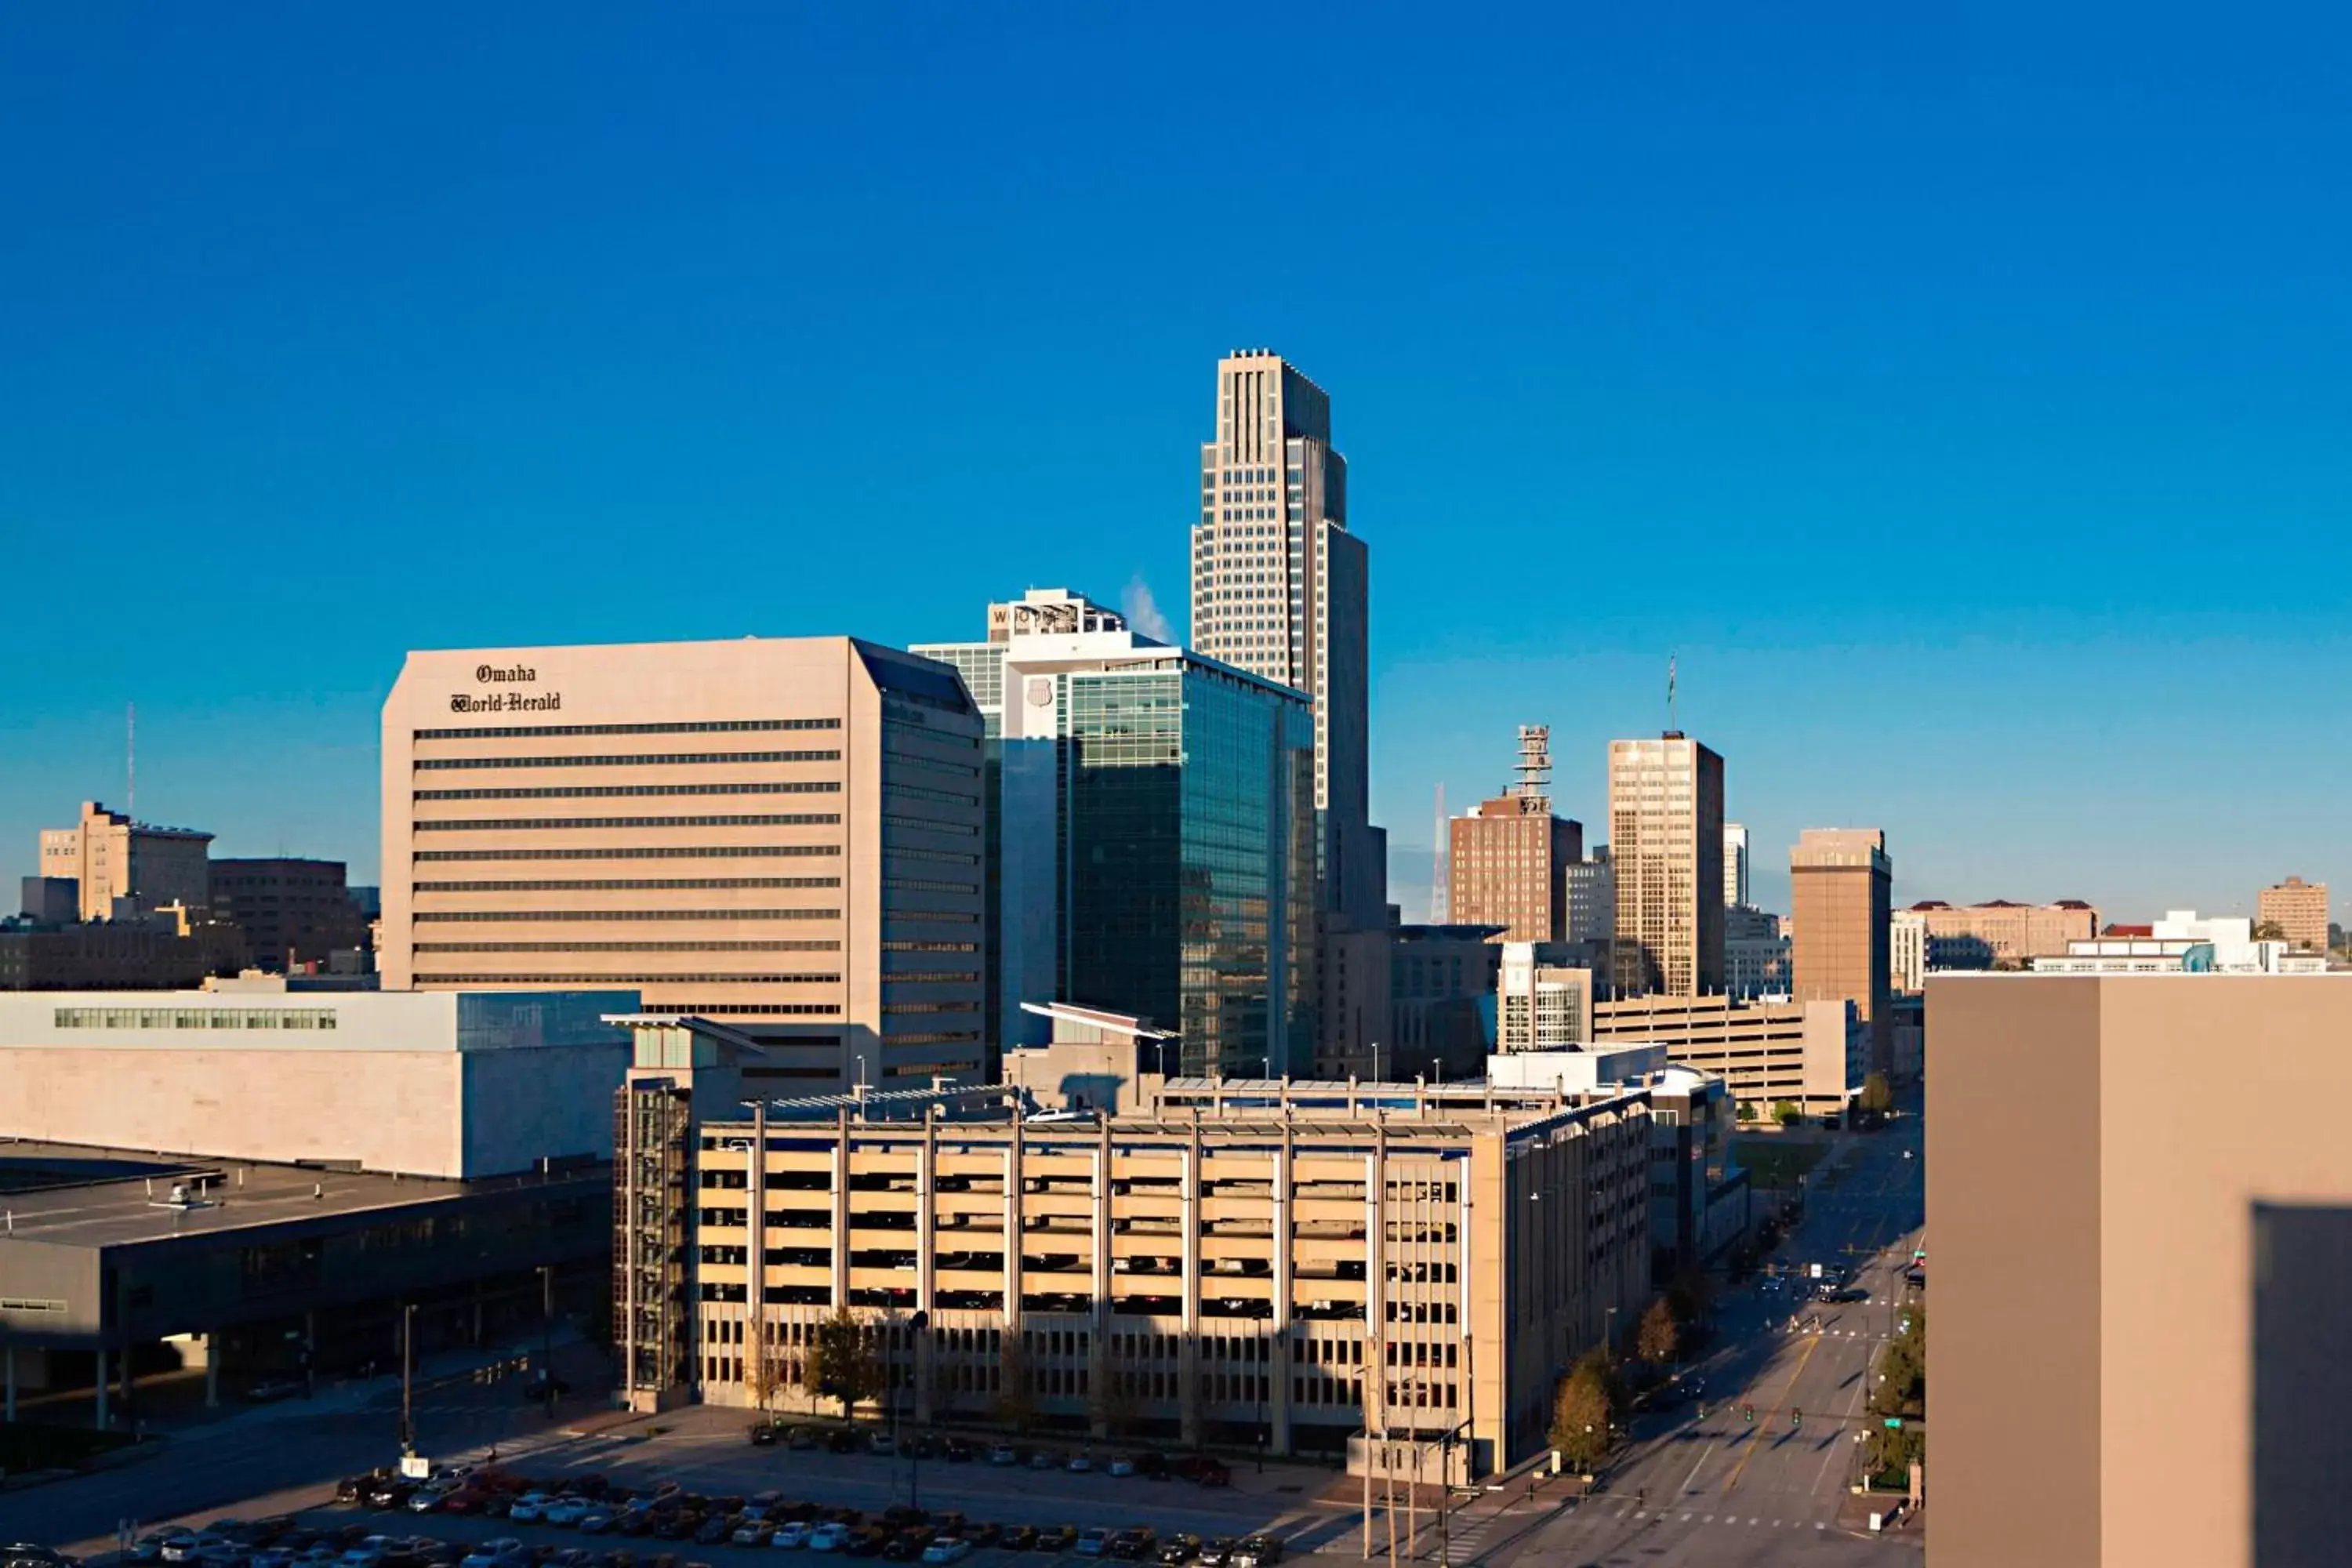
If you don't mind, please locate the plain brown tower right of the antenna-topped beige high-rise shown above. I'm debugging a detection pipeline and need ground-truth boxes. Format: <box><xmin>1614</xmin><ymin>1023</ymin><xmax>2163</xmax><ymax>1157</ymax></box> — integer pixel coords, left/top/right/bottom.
<box><xmin>1788</xmin><ymin>827</ymin><xmax>1896</xmax><ymax>1072</ymax></box>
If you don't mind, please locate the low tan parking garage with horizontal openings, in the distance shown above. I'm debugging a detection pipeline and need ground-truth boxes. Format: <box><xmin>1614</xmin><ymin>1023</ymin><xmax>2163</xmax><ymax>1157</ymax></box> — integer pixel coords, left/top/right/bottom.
<box><xmin>1592</xmin><ymin>996</ymin><xmax>1870</xmax><ymax>1116</ymax></box>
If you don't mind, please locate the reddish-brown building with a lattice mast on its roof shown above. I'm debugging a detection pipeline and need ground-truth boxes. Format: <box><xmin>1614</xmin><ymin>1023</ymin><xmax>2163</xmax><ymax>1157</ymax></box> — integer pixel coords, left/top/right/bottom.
<box><xmin>1446</xmin><ymin>724</ymin><xmax>1585</xmax><ymax>942</ymax></box>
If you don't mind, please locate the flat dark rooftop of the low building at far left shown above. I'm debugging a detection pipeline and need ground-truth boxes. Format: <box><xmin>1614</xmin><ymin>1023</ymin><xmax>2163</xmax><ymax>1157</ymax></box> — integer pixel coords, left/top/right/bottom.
<box><xmin>0</xmin><ymin>1138</ymin><xmax>607</xmax><ymax>1276</ymax></box>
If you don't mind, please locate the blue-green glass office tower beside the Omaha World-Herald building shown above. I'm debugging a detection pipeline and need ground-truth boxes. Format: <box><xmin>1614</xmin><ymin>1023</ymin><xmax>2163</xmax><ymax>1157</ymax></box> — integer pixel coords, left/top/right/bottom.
<box><xmin>917</xmin><ymin>590</ymin><xmax>1317</xmax><ymax>1076</ymax></box>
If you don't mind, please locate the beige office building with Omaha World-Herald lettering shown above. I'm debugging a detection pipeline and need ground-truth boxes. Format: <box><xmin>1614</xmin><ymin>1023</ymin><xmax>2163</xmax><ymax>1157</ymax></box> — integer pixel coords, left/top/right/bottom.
<box><xmin>381</xmin><ymin>637</ymin><xmax>985</xmax><ymax>1088</ymax></box>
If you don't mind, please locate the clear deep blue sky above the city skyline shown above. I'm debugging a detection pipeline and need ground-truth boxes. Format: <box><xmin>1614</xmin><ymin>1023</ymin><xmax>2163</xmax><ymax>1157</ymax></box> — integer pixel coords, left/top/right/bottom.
<box><xmin>0</xmin><ymin>2</ymin><xmax>2352</xmax><ymax>916</ymax></box>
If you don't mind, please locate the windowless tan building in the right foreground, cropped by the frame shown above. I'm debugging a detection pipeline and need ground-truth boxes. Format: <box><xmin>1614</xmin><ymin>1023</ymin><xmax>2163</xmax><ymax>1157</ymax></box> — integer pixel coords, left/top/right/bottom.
<box><xmin>1926</xmin><ymin>973</ymin><xmax>2352</xmax><ymax>1568</ymax></box>
